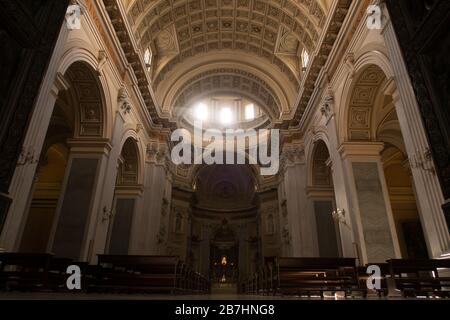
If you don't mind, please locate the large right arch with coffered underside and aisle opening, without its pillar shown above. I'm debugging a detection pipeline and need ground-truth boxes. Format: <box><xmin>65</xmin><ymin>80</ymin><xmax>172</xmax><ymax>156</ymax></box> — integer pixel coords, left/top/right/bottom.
<box><xmin>338</xmin><ymin>53</ymin><xmax>426</xmax><ymax>258</ymax></box>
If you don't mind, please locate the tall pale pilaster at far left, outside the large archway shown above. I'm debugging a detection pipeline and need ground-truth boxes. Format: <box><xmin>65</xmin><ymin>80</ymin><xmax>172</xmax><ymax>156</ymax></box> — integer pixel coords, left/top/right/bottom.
<box><xmin>0</xmin><ymin>24</ymin><xmax>69</xmax><ymax>251</ymax></box>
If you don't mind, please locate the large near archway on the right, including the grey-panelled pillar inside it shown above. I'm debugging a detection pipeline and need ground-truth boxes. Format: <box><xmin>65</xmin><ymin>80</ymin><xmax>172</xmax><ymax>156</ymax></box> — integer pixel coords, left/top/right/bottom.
<box><xmin>341</xmin><ymin>64</ymin><xmax>423</xmax><ymax>262</ymax></box>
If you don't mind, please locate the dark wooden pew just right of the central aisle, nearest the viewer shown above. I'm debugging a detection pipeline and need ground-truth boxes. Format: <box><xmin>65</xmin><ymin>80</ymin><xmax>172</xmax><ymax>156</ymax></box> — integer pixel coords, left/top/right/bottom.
<box><xmin>272</xmin><ymin>257</ymin><xmax>366</xmax><ymax>297</ymax></box>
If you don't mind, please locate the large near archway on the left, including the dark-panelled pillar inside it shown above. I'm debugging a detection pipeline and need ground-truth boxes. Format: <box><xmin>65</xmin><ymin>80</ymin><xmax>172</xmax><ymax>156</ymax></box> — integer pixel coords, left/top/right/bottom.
<box><xmin>20</xmin><ymin>61</ymin><xmax>104</xmax><ymax>259</ymax></box>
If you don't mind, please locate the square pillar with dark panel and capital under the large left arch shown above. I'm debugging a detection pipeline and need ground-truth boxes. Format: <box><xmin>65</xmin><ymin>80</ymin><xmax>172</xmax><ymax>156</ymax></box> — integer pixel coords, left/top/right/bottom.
<box><xmin>49</xmin><ymin>139</ymin><xmax>111</xmax><ymax>261</ymax></box>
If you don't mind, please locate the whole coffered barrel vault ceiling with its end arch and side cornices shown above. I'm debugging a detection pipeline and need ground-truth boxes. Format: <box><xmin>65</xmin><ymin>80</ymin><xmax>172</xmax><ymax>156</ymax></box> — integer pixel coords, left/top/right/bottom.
<box><xmin>103</xmin><ymin>0</ymin><xmax>352</xmax><ymax>128</ymax></box>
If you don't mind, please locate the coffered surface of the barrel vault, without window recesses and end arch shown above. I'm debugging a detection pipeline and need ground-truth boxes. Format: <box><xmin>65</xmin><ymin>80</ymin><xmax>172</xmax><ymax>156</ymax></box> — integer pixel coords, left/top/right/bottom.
<box><xmin>128</xmin><ymin>0</ymin><xmax>325</xmax><ymax>90</ymax></box>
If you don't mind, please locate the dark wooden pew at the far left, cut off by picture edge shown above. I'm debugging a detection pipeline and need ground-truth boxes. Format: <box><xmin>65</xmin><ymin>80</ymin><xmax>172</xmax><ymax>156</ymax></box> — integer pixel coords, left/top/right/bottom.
<box><xmin>0</xmin><ymin>252</ymin><xmax>53</xmax><ymax>291</ymax></box>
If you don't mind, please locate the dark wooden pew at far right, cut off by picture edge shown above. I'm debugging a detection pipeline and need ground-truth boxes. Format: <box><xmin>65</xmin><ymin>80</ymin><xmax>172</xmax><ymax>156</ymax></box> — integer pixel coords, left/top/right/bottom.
<box><xmin>388</xmin><ymin>259</ymin><xmax>450</xmax><ymax>297</ymax></box>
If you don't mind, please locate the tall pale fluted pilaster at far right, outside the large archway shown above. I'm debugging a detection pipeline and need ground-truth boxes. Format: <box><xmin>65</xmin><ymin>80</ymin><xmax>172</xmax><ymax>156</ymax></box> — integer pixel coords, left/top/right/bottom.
<box><xmin>382</xmin><ymin>10</ymin><xmax>450</xmax><ymax>258</ymax></box>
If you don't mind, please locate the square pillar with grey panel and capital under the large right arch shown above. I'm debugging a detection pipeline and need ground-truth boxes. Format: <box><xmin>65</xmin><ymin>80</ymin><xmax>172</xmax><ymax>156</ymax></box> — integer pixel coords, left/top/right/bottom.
<box><xmin>339</xmin><ymin>142</ymin><xmax>400</xmax><ymax>264</ymax></box>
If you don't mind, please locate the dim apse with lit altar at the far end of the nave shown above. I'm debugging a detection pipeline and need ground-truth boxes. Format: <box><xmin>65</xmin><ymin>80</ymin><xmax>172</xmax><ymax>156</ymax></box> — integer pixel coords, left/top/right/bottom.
<box><xmin>189</xmin><ymin>165</ymin><xmax>263</xmax><ymax>289</ymax></box>
